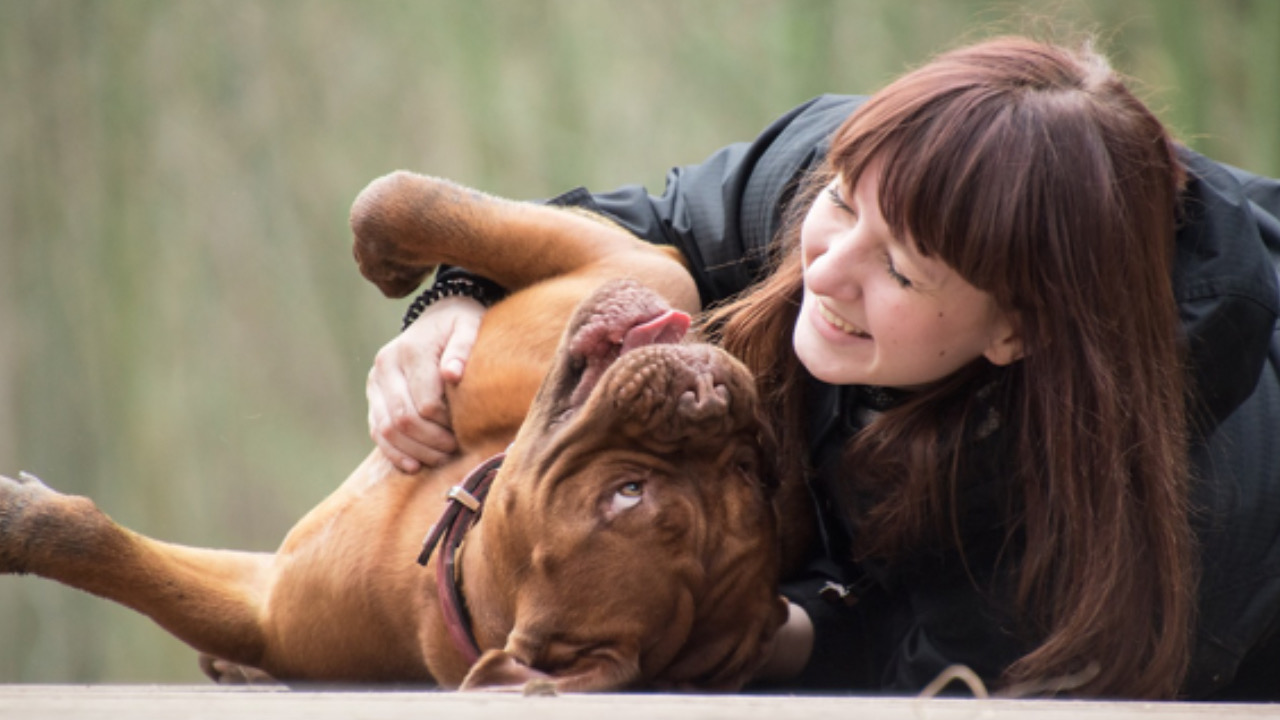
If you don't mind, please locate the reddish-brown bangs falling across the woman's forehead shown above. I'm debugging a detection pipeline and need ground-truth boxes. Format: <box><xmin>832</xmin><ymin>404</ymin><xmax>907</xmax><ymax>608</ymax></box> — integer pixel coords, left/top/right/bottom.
<box><xmin>831</xmin><ymin>86</ymin><xmax>1036</xmax><ymax>306</ymax></box>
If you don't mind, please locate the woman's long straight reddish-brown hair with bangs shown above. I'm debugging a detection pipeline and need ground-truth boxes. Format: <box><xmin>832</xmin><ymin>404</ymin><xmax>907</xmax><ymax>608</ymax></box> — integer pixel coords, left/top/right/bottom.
<box><xmin>709</xmin><ymin>38</ymin><xmax>1197</xmax><ymax>697</ymax></box>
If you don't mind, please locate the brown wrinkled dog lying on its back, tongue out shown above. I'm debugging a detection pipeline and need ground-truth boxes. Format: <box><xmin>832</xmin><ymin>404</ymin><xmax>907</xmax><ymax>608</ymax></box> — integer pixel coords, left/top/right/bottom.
<box><xmin>0</xmin><ymin>173</ymin><xmax>786</xmax><ymax>691</ymax></box>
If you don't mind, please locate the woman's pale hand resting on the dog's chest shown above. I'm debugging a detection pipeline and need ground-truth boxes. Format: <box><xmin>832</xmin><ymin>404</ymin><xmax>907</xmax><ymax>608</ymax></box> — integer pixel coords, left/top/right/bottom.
<box><xmin>365</xmin><ymin>297</ymin><xmax>485</xmax><ymax>473</ymax></box>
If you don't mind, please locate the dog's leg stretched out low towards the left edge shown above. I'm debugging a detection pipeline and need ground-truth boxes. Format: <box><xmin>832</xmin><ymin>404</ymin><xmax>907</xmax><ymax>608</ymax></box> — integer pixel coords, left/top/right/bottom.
<box><xmin>0</xmin><ymin>474</ymin><xmax>273</xmax><ymax>666</ymax></box>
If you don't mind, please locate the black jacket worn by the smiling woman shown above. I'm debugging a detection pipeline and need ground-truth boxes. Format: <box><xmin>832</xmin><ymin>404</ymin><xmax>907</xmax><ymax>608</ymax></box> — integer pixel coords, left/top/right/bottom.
<box><xmin>553</xmin><ymin>96</ymin><xmax>1280</xmax><ymax>697</ymax></box>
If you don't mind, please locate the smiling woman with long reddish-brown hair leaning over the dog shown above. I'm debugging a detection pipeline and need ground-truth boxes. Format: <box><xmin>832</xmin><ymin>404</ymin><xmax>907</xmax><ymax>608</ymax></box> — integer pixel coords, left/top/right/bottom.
<box><xmin>369</xmin><ymin>38</ymin><xmax>1280</xmax><ymax>697</ymax></box>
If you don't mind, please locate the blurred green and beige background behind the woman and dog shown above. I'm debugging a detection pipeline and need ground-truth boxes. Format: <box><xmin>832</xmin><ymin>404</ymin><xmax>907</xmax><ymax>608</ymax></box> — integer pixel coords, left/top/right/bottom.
<box><xmin>0</xmin><ymin>0</ymin><xmax>1280</xmax><ymax>683</ymax></box>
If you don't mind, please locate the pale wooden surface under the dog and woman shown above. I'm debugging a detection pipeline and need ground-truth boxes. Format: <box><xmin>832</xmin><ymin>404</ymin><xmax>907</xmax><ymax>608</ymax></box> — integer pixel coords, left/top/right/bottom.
<box><xmin>0</xmin><ymin>685</ymin><xmax>1280</xmax><ymax>720</ymax></box>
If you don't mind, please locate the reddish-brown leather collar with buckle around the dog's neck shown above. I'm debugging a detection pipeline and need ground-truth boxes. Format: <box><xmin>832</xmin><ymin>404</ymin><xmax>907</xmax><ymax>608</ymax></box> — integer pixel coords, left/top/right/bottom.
<box><xmin>417</xmin><ymin>452</ymin><xmax>507</xmax><ymax>665</ymax></box>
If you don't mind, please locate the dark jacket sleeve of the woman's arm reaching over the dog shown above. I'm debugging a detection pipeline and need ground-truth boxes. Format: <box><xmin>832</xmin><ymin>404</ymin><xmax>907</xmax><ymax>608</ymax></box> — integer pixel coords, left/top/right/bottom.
<box><xmin>552</xmin><ymin>95</ymin><xmax>861</xmax><ymax>305</ymax></box>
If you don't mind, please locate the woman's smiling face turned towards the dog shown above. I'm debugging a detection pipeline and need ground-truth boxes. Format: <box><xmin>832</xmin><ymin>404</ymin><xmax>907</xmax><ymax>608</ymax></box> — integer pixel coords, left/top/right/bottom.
<box><xmin>792</xmin><ymin>164</ymin><xmax>1021</xmax><ymax>389</ymax></box>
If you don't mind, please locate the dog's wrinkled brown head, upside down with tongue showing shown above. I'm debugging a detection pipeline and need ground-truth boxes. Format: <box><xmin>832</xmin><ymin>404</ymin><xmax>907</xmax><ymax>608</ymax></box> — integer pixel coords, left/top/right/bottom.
<box><xmin>463</xmin><ymin>282</ymin><xmax>786</xmax><ymax>691</ymax></box>
